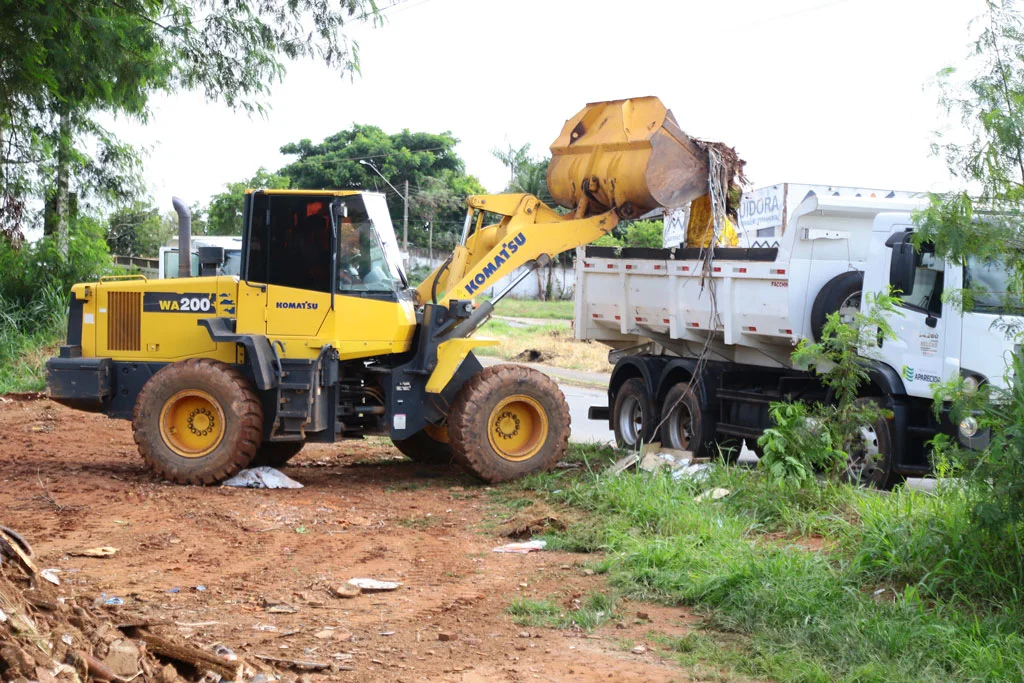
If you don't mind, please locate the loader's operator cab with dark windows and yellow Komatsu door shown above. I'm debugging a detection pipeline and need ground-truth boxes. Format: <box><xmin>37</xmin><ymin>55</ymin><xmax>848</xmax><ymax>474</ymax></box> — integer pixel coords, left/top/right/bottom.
<box><xmin>237</xmin><ymin>190</ymin><xmax>409</xmax><ymax>345</ymax></box>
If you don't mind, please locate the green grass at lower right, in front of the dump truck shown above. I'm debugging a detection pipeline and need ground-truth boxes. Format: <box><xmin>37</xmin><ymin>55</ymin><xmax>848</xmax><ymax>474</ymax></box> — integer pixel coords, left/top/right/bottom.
<box><xmin>509</xmin><ymin>446</ymin><xmax>1024</xmax><ymax>681</ymax></box>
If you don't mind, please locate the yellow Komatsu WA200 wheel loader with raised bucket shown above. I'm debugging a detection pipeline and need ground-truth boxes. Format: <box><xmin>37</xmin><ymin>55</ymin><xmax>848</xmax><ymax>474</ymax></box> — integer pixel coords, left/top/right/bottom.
<box><xmin>47</xmin><ymin>97</ymin><xmax>709</xmax><ymax>484</ymax></box>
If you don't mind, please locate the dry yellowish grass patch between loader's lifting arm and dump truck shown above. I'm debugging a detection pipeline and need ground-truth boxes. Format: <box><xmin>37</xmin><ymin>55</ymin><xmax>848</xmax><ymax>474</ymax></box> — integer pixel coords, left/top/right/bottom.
<box><xmin>474</xmin><ymin>319</ymin><xmax>611</xmax><ymax>373</ymax></box>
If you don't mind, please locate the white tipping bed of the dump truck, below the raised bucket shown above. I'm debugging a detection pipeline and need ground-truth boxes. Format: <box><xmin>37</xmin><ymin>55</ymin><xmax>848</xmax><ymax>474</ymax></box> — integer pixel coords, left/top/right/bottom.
<box><xmin>575</xmin><ymin>188</ymin><xmax>920</xmax><ymax>367</ymax></box>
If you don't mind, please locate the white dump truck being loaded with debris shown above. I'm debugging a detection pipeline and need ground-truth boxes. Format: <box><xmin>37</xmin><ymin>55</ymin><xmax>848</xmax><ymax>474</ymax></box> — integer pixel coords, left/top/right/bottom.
<box><xmin>575</xmin><ymin>185</ymin><xmax>1018</xmax><ymax>486</ymax></box>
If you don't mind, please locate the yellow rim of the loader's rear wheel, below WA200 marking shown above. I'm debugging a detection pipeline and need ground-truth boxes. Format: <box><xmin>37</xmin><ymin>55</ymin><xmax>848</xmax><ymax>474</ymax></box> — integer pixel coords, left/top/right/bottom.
<box><xmin>160</xmin><ymin>389</ymin><xmax>224</xmax><ymax>458</ymax></box>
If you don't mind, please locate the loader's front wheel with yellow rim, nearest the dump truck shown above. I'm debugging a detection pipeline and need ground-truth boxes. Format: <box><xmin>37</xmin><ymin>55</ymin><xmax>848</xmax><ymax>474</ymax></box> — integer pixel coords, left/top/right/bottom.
<box><xmin>449</xmin><ymin>365</ymin><xmax>569</xmax><ymax>482</ymax></box>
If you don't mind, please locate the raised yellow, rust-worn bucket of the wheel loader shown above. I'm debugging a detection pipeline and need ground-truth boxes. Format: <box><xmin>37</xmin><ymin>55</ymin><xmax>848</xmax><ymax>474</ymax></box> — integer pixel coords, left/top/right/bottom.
<box><xmin>548</xmin><ymin>97</ymin><xmax>708</xmax><ymax>218</ymax></box>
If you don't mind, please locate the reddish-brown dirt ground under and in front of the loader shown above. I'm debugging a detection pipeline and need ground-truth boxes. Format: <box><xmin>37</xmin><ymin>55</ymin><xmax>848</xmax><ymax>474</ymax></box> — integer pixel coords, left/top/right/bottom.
<box><xmin>0</xmin><ymin>399</ymin><xmax>693</xmax><ymax>683</ymax></box>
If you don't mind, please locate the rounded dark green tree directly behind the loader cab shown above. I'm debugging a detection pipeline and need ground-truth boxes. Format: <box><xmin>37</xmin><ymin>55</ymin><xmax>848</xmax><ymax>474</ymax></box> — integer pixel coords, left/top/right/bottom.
<box><xmin>279</xmin><ymin>124</ymin><xmax>485</xmax><ymax>247</ymax></box>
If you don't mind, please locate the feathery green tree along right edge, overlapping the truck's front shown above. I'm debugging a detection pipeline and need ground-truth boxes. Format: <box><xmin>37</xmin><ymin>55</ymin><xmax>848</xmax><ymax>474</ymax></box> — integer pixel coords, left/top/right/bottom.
<box><xmin>915</xmin><ymin>0</ymin><xmax>1024</xmax><ymax>532</ymax></box>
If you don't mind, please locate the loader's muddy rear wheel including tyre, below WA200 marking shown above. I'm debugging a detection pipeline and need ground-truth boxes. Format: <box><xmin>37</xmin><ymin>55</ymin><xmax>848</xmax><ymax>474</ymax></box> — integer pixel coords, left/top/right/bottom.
<box><xmin>132</xmin><ymin>358</ymin><xmax>263</xmax><ymax>484</ymax></box>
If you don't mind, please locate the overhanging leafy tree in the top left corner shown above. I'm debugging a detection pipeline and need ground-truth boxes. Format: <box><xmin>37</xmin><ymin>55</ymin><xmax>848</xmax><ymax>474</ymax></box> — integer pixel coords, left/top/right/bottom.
<box><xmin>0</xmin><ymin>0</ymin><xmax>378</xmax><ymax>246</ymax></box>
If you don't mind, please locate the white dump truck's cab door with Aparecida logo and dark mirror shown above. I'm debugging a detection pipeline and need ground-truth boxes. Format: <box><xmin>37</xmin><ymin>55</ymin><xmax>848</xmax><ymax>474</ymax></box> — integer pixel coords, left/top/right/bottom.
<box><xmin>878</xmin><ymin>229</ymin><xmax>959</xmax><ymax>398</ymax></box>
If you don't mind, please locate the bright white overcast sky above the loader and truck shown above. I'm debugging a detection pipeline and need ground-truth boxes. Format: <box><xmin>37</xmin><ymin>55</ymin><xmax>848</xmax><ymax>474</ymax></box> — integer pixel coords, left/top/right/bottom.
<box><xmin>105</xmin><ymin>0</ymin><xmax>984</xmax><ymax>214</ymax></box>
